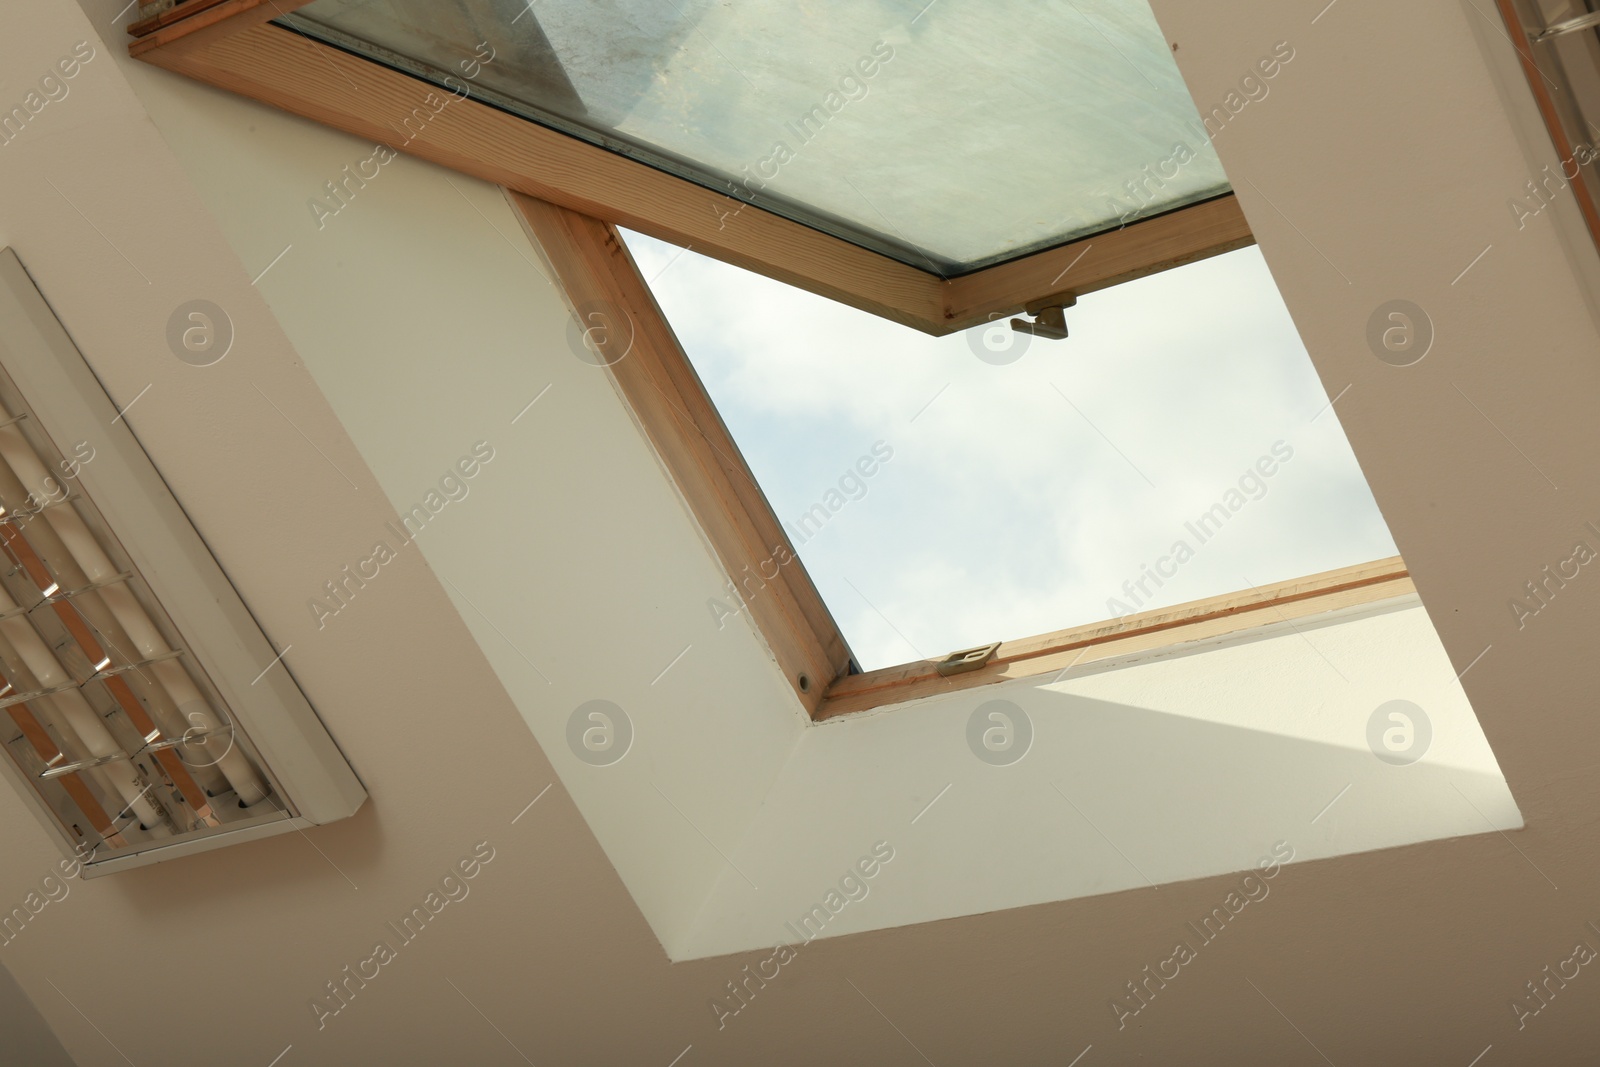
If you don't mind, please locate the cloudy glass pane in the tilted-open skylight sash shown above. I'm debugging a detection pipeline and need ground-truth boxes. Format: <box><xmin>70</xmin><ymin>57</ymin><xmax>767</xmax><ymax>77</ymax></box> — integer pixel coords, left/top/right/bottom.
<box><xmin>283</xmin><ymin>0</ymin><xmax>1229</xmax><ymax>275</ymax></box>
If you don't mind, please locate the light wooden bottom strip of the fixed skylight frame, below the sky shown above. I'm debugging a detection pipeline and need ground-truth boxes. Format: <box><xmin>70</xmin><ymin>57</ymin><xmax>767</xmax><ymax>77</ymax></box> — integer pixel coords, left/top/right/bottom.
<box><xmin>814</xmin><ymin>557</ymin><xmax>1416</xmax><ymax>720</ymax></box>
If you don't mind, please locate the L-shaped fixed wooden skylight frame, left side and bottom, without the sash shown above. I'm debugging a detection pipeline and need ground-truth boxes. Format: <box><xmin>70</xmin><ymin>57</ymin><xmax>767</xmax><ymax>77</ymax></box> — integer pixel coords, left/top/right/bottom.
<box><xmin>507</xmin><ymin>190</ymin><xmax>1416</xmax><ymax>721</ymax></box>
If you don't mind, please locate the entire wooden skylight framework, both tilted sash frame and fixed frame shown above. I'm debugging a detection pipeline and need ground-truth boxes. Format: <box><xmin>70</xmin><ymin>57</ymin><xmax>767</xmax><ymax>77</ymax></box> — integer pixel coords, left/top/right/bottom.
<box><xmin>130</xmin><ymin>0</ymin><xmax>1414</xmax><ymax>721</ymax></box>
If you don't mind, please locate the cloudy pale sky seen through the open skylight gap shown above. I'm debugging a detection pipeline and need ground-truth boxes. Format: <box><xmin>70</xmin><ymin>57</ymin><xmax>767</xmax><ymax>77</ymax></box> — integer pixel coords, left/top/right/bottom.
<box><xmin>626</xmin><ymin>232</ymin><xmax>1395</xmax><ymax>670</ymax></box>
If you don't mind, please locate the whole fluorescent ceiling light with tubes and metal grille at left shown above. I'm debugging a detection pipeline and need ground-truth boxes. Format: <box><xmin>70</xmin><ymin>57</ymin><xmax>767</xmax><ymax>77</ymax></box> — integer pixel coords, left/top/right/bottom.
<box><xmin>0</xmin><ymin>250</ymin><xmax>366</xmax><ymax>875</ymax></box>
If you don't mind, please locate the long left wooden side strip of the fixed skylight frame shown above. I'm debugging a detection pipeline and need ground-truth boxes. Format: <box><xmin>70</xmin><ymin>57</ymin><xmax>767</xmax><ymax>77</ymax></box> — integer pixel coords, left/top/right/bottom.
<box><xmin>507</xmin><ymin>190</ymin><xmax>850</xmax><ymax>713</ymax></box>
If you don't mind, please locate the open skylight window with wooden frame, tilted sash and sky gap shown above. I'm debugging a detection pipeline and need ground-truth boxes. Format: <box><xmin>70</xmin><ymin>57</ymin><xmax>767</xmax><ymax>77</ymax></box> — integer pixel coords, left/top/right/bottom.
<box><xmin>130</xmin><ymin>0</ymin><xmax>1410</xmax><ymax>718</ymax></box>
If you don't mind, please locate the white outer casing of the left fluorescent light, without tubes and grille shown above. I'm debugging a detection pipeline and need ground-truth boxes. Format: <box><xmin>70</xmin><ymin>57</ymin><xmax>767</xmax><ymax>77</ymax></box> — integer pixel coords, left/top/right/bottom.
<box><xmin>0</xmin><ymin>248</ymin><xmax>366</xmax><ymax>878</ymax></box>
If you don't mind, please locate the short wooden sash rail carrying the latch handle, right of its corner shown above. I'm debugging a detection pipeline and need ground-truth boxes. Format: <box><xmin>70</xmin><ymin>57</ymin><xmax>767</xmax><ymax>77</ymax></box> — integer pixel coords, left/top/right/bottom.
<box><xmin>944</xmin><ymin>194</ymin><xmax>1256</xmax><ymax>331</ymax></box>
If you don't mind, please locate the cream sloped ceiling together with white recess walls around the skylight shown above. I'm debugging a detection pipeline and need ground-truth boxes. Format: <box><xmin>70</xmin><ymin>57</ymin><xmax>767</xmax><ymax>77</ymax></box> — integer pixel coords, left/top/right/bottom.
<box><xmin>0</xmin><ymin>0</ymin><xmax>1600</xmax><ymax>1067</ymax></box>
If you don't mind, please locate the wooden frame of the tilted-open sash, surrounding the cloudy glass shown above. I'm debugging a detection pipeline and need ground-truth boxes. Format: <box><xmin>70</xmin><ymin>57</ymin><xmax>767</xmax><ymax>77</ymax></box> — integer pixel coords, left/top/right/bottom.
<box><xmin>128</xmin><ymin>0</ymin><xmax>1254</xmax><ymax>336</ymax></box>
